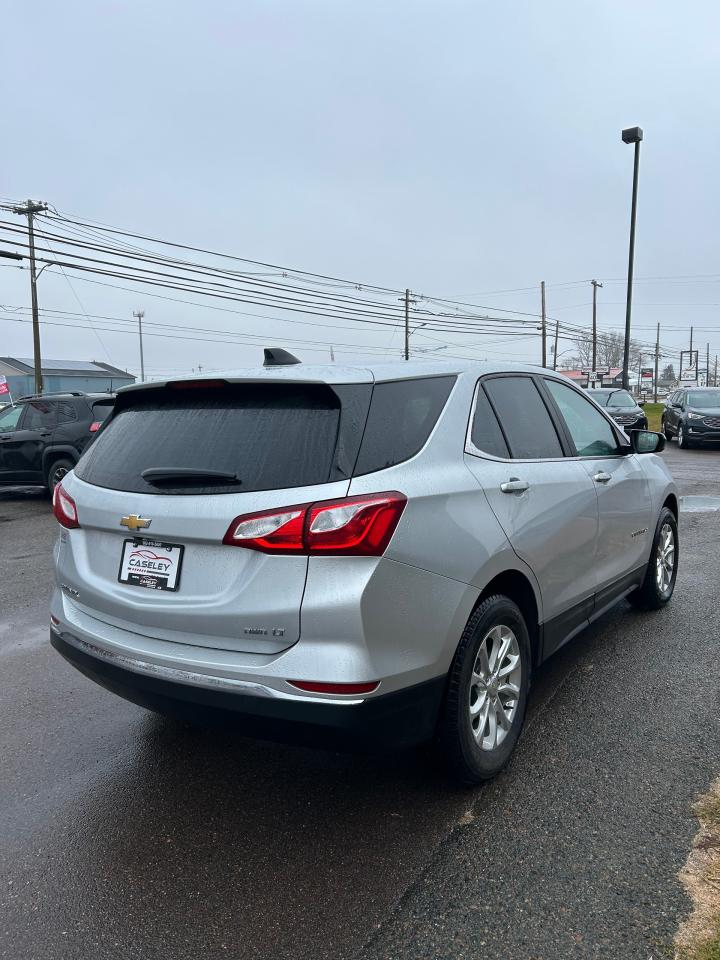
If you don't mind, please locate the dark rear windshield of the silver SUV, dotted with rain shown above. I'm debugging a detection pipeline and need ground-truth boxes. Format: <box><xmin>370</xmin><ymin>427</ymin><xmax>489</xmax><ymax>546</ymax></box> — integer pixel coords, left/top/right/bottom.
<box><xmin>75</xmin><ymin>384</ymin><xmax>370</xmax><ymax>494</ymax></box>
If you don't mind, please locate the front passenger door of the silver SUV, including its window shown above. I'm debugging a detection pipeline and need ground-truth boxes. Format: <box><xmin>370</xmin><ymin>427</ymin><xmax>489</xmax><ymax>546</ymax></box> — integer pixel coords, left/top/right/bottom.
<box><xmin>543</xmin><ymin>377</ymin><xmax>655</xmax><ymax>606</ymax></box>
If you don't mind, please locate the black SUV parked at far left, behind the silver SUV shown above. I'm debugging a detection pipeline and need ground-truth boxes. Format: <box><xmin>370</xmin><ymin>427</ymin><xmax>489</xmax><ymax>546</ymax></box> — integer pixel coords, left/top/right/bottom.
<box><xmin>0</xmin><ymin>393</ymin><xmax>115</xmax><ymax>492</ymax></box>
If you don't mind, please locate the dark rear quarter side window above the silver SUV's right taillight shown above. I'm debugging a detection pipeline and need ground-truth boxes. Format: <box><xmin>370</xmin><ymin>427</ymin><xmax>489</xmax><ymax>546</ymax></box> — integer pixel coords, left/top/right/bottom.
<box><xmin>355</xmin><ymin>377</ymin><xmax>455</xmax><ymax>476</ymax></box>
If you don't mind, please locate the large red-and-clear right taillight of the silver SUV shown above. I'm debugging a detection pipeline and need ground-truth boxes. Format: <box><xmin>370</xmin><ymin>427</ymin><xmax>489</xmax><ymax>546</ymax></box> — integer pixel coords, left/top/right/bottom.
<box><xmin>223</xmin><ymin>490</ymin><xmax>407</xmax><ymax>557</ymax></box>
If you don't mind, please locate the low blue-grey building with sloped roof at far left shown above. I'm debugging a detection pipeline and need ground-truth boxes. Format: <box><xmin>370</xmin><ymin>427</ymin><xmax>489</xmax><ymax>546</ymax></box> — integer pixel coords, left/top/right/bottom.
<box><xmin>0</xmin><ymin>357</ymin><xmax>135</xmax><ymax>398</ymax></box>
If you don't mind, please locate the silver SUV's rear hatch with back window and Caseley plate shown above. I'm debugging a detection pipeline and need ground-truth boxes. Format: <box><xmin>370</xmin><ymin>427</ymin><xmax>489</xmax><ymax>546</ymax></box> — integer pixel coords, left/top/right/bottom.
<box><xmin>64</xmin><ymin>380</ymin><xmax>372</xmax><ymax>653</ymax></box>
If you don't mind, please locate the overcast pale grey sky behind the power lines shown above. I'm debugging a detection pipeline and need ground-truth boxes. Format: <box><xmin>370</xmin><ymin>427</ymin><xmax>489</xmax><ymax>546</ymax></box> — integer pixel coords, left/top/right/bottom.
<box><xmin>0</xmin><ymin>0</ymin><xmax>720</xmax><ymax>374</ymax></box>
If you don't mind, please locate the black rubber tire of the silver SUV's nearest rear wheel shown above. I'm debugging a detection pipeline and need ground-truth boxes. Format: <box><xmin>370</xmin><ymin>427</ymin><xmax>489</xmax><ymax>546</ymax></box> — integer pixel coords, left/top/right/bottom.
<box><xmin>440</xmin><ymin>595</ymin><xmax>532</xmax><ymax>783</ymax></box>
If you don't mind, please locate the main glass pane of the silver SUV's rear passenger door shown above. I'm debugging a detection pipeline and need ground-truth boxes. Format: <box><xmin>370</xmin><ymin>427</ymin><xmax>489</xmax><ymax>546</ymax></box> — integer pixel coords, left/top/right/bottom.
<box><xmin>484</xmin><ymin>376</ymin><xmax>564</xmax><ymax>460</ymax></box>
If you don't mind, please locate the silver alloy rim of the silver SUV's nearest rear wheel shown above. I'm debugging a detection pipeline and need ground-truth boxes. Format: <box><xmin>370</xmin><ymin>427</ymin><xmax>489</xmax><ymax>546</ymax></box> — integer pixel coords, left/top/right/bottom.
<box><xmin>468</xmin><ymin>624</ymin><xmax>522</xmax><ymax>750</ymax></box>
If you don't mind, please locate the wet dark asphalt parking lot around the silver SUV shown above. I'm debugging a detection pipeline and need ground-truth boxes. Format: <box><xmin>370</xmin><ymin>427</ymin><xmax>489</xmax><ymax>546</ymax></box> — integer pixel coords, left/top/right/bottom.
<box><xmin>0</xmin><ymin>443</ymin><xmax>720</xmax><ymax>960</ymax></box>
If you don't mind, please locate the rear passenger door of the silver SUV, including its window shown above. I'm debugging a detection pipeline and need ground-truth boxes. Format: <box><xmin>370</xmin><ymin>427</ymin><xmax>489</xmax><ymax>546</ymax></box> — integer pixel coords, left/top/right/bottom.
<box><xmin>466</xmin><ymin>374</ymin><xmax>598</xmax><ymax>638</ymax></box>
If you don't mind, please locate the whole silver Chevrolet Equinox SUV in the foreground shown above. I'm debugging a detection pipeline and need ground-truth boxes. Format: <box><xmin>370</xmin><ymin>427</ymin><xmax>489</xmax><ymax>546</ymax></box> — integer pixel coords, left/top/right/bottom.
<box><xmin>51</xmin><ymin>351</ymin><xmax>678</xmax><ymax>782</ymax></box>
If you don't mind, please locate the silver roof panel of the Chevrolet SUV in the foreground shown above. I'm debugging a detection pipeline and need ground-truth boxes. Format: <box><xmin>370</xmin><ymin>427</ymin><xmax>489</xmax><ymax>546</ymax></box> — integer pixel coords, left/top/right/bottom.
<box><xmin>118</xmin><ymin>358</ymin><xmax>566</xmax><ymax>394</ymax></box>
